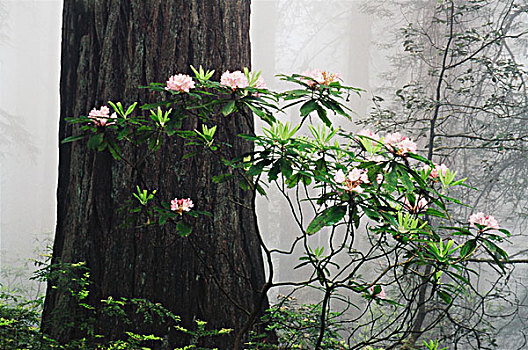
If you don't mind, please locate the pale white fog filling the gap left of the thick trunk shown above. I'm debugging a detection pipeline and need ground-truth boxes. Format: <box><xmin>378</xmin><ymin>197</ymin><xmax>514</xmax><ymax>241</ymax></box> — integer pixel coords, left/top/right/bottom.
<box><xmin>0</xmin><ymin>1</ymin><xmax>62</xmax><ymax>296</ymax></box>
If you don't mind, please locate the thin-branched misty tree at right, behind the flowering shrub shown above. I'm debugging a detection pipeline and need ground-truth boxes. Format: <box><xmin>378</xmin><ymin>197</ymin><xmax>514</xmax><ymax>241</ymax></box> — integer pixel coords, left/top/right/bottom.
<box><xmin>365</xmin><ymin>0</ymin><xmax>528</xmax><ymax>349</ymax></box>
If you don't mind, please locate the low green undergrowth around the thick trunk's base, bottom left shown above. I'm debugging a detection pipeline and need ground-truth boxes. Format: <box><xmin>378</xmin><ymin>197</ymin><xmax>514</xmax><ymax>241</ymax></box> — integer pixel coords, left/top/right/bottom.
<box><xmin>0</xmin><ymin>261</ymin><xmax>231</xmax><ymax>350</ymax></box>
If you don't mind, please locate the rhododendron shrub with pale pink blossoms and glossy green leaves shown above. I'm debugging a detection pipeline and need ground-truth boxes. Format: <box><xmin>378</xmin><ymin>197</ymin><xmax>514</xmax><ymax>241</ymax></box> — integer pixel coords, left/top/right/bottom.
<box><xmin>65</xmin><ymin>67</ymin><xmax>509</xmax><ymax>348</ymax></box>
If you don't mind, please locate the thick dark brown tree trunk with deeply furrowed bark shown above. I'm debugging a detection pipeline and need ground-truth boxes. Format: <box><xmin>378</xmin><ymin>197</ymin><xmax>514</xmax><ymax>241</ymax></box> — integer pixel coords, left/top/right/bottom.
<box><xmin>43</xmin><ymin>0</ymin><xmax>264</xmax><ymax>349</ymax></box>
